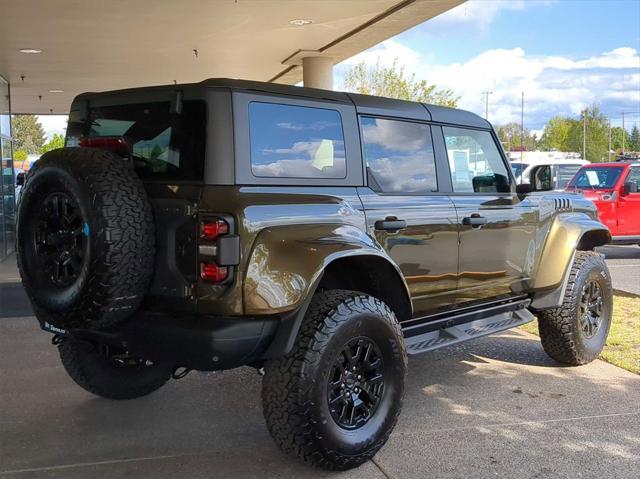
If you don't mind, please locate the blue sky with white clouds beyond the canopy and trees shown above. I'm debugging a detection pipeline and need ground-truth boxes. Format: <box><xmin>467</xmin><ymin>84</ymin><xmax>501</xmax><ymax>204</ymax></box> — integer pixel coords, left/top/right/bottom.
<box><xmin>40</xmin><ymin>0</ymin><xmax>640</xmax><ymax>140</ymax></box>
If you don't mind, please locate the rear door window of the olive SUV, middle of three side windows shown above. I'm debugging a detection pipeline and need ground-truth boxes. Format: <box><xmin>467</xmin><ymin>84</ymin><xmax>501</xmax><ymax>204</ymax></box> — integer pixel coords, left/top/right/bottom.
<box><xmin>360</xmin><ymin>117</ymin><xmax>438</xmax><ymax>193</ymax></box>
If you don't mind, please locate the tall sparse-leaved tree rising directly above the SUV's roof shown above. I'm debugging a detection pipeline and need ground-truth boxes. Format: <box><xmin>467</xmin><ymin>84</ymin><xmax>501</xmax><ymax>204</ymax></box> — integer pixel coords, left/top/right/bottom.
<box><xmin>344</xmin><ymin>59</ymin><xmax>460</xmax><ymax>107</ymax></box>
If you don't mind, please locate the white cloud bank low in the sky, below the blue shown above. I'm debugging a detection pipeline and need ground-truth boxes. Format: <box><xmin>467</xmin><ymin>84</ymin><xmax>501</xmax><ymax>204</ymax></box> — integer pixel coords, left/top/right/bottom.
<box><xmin>338</xmin><ymin>41</ymin><xmax>640</xmax><ymax>129</ymax></box>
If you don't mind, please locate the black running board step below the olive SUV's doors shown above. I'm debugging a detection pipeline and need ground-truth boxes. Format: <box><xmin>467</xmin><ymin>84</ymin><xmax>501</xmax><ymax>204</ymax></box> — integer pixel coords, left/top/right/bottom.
<box><xmin>405</xmin><ymin>309</ymin><xmax>534</xmax><ymax>355</ymax></box>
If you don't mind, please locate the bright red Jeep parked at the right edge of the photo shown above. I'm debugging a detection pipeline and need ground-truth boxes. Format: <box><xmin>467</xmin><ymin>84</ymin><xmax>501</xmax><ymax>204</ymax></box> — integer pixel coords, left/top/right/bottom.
<box><xmin>567</xmin><ymin>162</ymin><xmax>640</xmax><ymax>245</ymax></box>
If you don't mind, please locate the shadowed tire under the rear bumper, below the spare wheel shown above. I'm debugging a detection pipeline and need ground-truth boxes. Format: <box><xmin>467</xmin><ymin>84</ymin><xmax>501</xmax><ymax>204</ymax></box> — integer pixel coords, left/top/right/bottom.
<box><xmin>58</xmin><ymin>337</ymin><xmax>173</xmax><ymax>399</ymax></box>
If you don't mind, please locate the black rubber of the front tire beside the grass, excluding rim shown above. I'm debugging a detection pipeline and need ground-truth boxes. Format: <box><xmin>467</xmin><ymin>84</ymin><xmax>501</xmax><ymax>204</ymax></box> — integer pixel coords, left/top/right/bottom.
<box><xmin>538</xmin><ymin>251</ymin><xmax>613</xmax><ymax>366</ymax></box>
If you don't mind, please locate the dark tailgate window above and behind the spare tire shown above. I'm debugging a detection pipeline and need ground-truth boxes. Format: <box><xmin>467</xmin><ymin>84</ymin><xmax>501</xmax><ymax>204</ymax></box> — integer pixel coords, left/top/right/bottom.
<box><xmin>67</xmin><ymin>101</ymin><xmax>206</xmax><ymax>181</ymax></box>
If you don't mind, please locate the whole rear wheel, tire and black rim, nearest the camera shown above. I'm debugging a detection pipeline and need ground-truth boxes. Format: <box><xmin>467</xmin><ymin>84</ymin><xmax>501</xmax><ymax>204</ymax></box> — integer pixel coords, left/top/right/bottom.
<box><xmin>262</xmin><ymin>290</ymin><xmax>407</xmax><ymax>470</ymax></box>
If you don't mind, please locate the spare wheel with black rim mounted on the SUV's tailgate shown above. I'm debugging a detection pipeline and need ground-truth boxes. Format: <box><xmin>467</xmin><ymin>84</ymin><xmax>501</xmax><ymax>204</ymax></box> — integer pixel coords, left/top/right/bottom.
<box><xmin>17</xmin><ymin>148</ymin><xmax>155</xmax><ymax>329</ymax></box>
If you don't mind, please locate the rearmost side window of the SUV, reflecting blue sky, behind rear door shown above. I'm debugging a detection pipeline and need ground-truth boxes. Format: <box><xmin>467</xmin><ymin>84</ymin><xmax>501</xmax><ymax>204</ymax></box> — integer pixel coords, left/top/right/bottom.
<box><xmin>249</xmin><ymin>102</ymin><xmax>347</xmax><ymax>178</ymax></box>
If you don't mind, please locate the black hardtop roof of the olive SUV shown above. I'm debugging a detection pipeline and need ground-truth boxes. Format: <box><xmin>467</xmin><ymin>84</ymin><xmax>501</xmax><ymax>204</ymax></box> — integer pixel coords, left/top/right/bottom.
<box><xmin>74</xmin><ymin>78</ymin><xmax>491</xmax><ymax>128</ymax></box>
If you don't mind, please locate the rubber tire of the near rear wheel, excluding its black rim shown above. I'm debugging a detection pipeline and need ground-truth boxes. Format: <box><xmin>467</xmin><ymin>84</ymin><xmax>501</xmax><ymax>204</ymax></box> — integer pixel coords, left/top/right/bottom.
<box><xmin>262</xmin><ymin>290</ymin><xmax>407</xmax><ymax>470</ymax></box>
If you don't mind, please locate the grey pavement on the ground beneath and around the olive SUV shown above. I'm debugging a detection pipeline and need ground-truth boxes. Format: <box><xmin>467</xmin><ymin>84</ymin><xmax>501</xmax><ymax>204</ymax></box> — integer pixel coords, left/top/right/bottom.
<box><xmin>0</xmin><ymin>248</ymin><xmax>640</xmax><ymax>478</ymax></box>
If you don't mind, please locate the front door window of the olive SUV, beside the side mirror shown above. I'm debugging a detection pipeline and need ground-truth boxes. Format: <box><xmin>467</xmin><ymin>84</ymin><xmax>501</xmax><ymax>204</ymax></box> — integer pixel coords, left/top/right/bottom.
<box><xmin>442</xmin><ymin>127</ymin><xmax>511</xmax><ymax>193</ymax></box>
